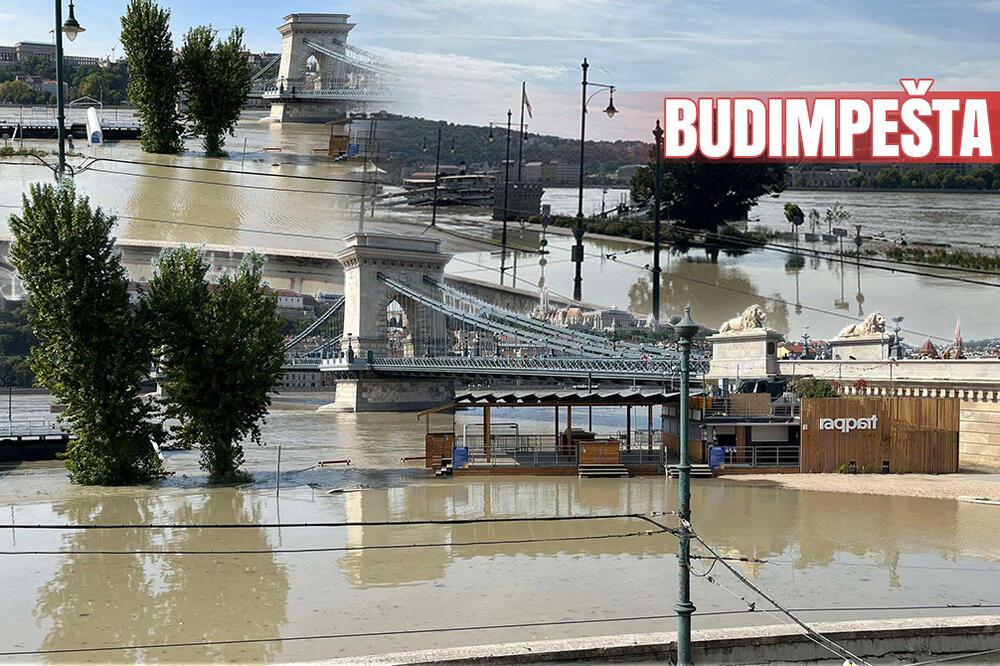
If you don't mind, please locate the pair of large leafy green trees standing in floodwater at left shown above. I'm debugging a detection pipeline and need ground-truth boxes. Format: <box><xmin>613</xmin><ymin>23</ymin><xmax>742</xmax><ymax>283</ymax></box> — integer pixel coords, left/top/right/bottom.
<box><xmin>9</xmin><ymin>181</ymin><xmax>284</xmax><ymax>485</ymax></box>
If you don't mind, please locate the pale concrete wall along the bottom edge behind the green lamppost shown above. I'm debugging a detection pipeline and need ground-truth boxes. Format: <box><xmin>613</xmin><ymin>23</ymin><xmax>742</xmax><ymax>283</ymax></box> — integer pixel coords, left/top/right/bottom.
<box><xmin>311</xmin><ymin>615</ymin><xmax>1000</xmax><ymax>666</ymax></box>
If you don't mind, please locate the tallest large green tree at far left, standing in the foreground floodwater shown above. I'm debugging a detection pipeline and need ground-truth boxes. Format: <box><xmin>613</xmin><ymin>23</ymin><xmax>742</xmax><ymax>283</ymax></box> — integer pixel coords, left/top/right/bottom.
<box><xmin>9</xmin><ymin>183</ymin><xmax>162</xmax><ymax>485</ymax></box>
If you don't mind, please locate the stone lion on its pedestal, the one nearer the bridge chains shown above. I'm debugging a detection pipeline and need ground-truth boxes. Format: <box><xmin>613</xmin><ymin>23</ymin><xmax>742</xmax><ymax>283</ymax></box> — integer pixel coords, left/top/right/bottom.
<box><xmin>707</xmin><ymin>305</ymin><xmax>785</xmax><ymax>379</ymax></box>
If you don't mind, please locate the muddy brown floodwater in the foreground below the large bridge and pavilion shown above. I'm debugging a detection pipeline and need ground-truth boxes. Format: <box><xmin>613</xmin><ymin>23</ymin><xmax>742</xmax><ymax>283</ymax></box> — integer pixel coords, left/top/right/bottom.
<box><xmin>0</xmin><ymin>396</ymin><xmax>1000</xmax><ymax>663</ymax></box>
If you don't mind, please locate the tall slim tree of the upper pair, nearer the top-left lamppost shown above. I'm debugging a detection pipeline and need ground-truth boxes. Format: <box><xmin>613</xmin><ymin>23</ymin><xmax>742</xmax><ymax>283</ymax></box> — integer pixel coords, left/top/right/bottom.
<box><xmin>121</xmin><ymin>0</ymin><xmax>184</xmax><ymax>153</ymax></box>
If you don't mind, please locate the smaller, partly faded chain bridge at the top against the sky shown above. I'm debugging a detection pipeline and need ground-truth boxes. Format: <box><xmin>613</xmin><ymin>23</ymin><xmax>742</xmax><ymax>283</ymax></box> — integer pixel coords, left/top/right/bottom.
<box><xmin>250</xmin><ymin>14</ymin><xmax>395</xmax><ymax>122</ymax></box>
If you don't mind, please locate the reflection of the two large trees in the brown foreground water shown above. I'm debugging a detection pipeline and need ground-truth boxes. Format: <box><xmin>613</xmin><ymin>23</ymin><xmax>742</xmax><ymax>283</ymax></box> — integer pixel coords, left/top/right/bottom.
<box><xmin>33</xmin><ymin>490</ymin><xmax>289</xmax><ymax>663</ymax></box>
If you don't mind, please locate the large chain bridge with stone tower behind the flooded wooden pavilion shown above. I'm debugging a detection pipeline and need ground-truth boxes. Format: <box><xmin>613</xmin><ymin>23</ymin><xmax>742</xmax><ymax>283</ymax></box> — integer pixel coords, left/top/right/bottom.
<box><xmin>278</xmin><ymin>234</ymin><xmax>708</xmax><ymax>411</ymax></box>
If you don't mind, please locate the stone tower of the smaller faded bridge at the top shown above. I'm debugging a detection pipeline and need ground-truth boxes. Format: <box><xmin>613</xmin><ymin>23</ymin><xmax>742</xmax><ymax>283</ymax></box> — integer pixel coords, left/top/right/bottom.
<box><xmin>271</xmin><ymin>14</ymin><xmax>355</xmax><ymax>122</ymax></box>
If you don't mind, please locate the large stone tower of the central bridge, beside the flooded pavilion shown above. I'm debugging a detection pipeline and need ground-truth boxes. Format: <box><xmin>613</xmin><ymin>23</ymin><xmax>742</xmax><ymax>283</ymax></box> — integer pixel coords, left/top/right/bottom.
<box><xmin>328</xmin><ymin>233</ymin><xmax>454</xmax><ymax>412</ymax></box>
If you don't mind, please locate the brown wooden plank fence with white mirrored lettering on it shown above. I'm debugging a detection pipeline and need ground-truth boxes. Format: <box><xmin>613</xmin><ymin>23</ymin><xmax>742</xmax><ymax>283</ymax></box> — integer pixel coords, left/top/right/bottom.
<box><xmin>800</xmin><ymin>397</ymin><xmax>960</xmax><ymax>474</ymax></box>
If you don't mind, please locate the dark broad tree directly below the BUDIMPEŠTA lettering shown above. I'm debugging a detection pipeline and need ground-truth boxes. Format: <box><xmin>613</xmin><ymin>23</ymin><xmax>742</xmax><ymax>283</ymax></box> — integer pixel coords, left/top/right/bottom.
<box><xmin>632</xmin><ymin>161</ymin><xmax>785</xmax><ymax>231</ymax></box>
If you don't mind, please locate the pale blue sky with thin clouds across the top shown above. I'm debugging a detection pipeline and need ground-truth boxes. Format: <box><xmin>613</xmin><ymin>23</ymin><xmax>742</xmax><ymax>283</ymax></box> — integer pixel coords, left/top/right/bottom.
<box><xmin>7</xmin><ymin>0</ymin><xmax>1000</xmax><ymax>140</ymax></box>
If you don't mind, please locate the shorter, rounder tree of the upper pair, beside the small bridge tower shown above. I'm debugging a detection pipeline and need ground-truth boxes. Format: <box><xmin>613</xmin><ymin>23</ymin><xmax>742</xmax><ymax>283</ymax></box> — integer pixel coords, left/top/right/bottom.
<box><xmin>178</xmin><ymin>25</ymin><xmax>253</xmax><ymax>155</ymax></box>
